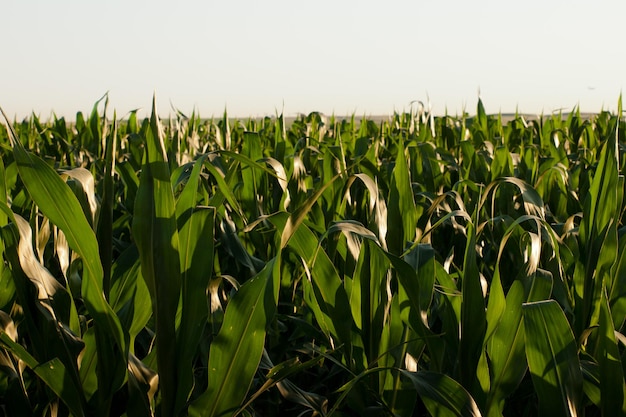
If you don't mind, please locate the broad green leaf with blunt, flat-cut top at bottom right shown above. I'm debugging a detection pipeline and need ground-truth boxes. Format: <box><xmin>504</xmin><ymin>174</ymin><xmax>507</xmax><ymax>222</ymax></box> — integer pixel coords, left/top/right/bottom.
<box><xmin>523</xmin><ymin>300</ymin><xmax>583</xmax><ymax>417</ymax></box>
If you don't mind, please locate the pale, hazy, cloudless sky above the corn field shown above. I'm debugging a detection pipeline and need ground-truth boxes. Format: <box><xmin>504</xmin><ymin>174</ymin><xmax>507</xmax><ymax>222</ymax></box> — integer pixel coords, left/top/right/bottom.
<box><xmin>0</xmin><ymin>0</ymin><xmax>626</xmax><ymax>119</ymax></box>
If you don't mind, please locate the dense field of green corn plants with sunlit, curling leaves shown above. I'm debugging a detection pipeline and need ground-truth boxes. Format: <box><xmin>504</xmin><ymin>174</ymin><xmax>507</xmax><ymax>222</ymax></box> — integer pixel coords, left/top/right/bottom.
<box><xmin>0</xmin><ymin>98</ymin><xmax>626</xmax><ymax>417</ymax></box>
